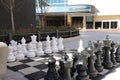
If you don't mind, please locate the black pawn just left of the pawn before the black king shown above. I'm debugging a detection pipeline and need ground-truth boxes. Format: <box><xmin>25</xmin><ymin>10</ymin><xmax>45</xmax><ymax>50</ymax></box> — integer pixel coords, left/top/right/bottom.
<box><xmin>95</xmin><ymin>51</ymin><xmax>103</xmax><ymax>72</ymax></box>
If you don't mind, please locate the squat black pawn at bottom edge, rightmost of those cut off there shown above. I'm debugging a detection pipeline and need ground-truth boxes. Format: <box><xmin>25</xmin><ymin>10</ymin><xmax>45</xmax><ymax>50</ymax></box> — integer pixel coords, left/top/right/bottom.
<box><xmin>75</xmin><ymin>64</ymin><xmax>90</xmax><ymax>80</ymax></box>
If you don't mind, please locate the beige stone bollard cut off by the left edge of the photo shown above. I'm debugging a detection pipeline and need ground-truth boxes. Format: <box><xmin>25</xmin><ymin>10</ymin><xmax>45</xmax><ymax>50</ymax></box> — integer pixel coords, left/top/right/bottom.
<box><xmin>0</xmin><ymin>42</ymin><xmax>8</xmax><ymax>76</ymax></box>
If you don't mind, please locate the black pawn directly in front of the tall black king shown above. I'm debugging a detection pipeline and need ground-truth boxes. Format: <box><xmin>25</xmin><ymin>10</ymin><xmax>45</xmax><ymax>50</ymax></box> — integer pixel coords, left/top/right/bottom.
<box><xmin>103</xmin><ymin>46</ymin><xmax>113</xmax><ymax>69</ymax></box>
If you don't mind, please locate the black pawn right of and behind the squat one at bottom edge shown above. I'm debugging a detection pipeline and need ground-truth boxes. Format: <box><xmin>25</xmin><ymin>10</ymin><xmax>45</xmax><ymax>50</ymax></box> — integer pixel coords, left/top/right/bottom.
<box><xmin>87</xmin><ymin>56</ymin><xmax>98</xmax><ymax>78</ymax></box>
